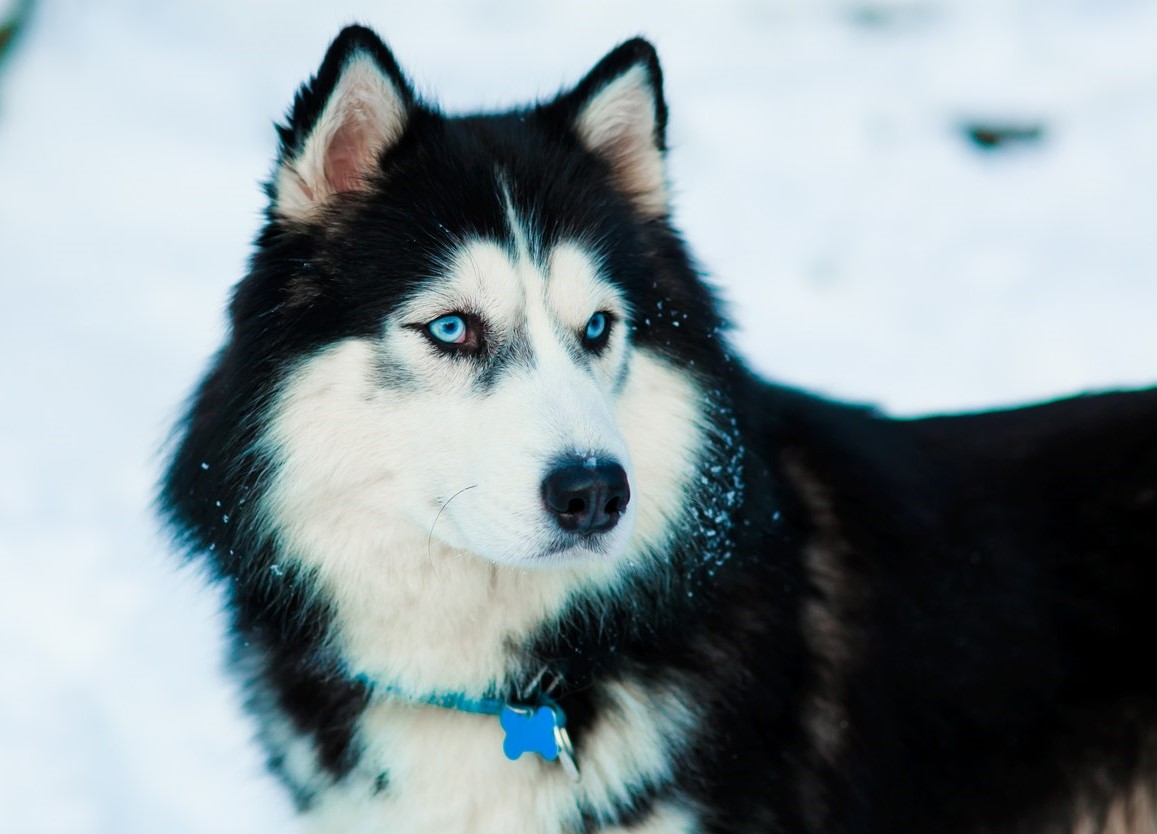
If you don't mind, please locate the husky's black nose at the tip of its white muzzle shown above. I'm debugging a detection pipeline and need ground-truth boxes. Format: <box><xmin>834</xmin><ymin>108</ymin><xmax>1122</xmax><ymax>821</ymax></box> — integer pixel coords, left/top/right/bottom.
<box><xmin>543</xmin><ymin>462</ymin><xmax>631</xmax><ymax>536</ymax></box>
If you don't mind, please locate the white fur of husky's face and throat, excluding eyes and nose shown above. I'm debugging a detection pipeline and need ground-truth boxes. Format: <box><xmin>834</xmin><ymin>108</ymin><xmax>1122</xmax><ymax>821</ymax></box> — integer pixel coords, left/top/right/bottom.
<box><xmin>261</xmin><ymin>231</ymin><xmax>706</xmax><ymax>692</ymax></box>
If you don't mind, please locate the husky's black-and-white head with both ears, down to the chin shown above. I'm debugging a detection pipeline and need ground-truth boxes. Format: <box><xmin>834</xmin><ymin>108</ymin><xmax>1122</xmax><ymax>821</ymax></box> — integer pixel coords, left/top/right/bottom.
<box><xmin>234</xmin><ymin>29</ymin><xmax>710</xmax><ymax>567</ymax></box>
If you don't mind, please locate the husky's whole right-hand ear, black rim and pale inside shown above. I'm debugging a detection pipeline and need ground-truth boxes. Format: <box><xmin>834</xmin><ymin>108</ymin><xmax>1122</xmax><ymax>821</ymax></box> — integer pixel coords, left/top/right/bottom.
<box><xmin>557</xmin><ymin>38</ymin><xmax>668</xmax><ymax>217</ymax></box>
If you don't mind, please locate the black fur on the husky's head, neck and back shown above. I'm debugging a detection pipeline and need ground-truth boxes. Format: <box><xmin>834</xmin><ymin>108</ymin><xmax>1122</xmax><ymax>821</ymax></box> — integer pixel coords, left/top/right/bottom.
<box><xmin>160</xmin><ymin>28</ymin><xmax>1157</xmax><ymax>834</ymax></box>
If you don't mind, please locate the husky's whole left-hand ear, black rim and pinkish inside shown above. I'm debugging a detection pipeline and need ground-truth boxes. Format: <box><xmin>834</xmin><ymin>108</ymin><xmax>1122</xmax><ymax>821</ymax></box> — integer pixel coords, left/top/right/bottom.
<box><xmin>270</xmin><ymin>25</ymin><xmax>414</xmax><ymax>220</ymax></box>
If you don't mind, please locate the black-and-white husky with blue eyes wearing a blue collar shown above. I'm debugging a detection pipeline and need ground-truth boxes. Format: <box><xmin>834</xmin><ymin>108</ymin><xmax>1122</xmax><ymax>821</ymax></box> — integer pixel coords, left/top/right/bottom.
<box><xmin>159</xmin><ymin>27</ymin><xmax>1157</xmax><ymax>834</ymax></box>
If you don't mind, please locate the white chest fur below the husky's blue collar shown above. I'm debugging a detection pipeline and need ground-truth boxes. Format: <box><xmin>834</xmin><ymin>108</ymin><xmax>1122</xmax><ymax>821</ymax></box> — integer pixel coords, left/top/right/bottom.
<box><xmin>293</xmin><ymin>684</ymin><xmax>695</xmax><ymax>834</ymax></box>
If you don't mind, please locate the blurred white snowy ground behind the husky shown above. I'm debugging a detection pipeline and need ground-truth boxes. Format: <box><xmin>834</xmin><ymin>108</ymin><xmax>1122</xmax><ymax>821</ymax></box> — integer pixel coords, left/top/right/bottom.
<box><xmin>0</xmin><ymin>0</ymin><xmax>1157</xmax><ymax>834</ymax></box>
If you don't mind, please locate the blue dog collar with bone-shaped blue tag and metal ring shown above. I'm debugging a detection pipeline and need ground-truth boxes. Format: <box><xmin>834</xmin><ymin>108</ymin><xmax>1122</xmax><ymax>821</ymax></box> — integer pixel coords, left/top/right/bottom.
<box><xmin>355</xmin><ymin>674</ymin><xmax>579</xmax><ymax>781</ymax></box>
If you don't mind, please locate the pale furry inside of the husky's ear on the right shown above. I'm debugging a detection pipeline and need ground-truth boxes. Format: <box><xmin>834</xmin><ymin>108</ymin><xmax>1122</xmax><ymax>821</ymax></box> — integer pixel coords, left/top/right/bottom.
<box><xmin>575</xmin><ymin>65</ymin><xmax>668</xmax><ymax>216</ymax></box>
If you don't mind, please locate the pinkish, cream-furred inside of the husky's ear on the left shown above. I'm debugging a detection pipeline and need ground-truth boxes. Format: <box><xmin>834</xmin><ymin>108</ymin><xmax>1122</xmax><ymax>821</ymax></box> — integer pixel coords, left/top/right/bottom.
<box><xmin>274</xmin><ymin>52</ymin><xmax>406</xmax><ymax>220</ymax></box>
